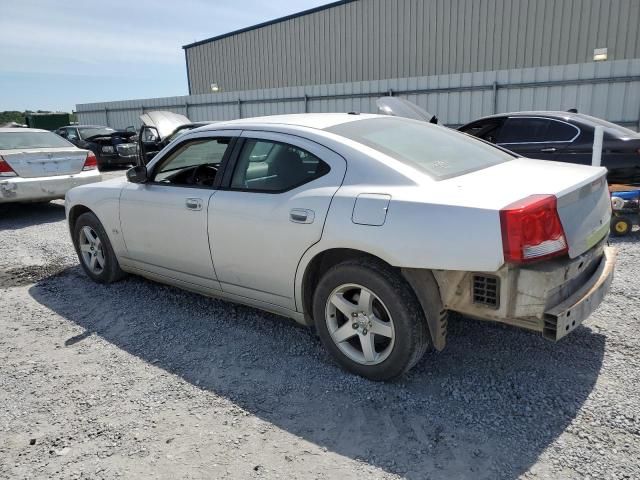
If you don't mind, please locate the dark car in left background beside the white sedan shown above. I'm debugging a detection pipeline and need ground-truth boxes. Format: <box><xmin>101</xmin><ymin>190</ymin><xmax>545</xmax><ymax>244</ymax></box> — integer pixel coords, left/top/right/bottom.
<box><xmin>56</xmin><ymin>125</ymin><xmax>138</xmax><ymax>169</ymax></box>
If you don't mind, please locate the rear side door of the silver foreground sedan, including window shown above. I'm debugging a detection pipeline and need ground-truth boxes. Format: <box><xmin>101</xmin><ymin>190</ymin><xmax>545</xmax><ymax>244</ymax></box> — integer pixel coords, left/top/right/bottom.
<box><xmin>208</xmin><ymin>131</ymin><xmax>346</xmax><ymax>310</ymax></box>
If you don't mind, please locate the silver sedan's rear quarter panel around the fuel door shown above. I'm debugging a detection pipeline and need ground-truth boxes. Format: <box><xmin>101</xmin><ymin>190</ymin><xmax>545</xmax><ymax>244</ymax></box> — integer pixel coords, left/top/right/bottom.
<box><xmin>295</xmin><ymin>185</ymin><xmax>504</xmax><ymax>312</ymax></box>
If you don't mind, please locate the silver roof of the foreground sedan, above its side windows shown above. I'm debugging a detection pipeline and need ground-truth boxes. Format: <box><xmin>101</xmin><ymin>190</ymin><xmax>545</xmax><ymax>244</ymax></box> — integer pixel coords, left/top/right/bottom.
<box><xmin>203</xmin><ymin>113</ymin><xmax>384</xmax><ymax>129</ymax></box>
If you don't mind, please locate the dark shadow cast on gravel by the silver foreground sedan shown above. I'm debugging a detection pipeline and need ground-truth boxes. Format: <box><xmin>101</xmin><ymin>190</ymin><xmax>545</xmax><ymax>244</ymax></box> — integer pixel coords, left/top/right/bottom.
<box><xmin>30</xmin><ymin>267</ymin><xmax>605</xmax><ymax>479</ymax></box>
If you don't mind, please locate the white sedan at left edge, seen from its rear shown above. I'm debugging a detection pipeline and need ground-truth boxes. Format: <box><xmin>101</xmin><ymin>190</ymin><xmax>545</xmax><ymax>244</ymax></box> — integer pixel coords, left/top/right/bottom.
<box><xmin>0</xmin><ymin>128</ymin><xmax>101</xmax><ymax>203</ymax></box>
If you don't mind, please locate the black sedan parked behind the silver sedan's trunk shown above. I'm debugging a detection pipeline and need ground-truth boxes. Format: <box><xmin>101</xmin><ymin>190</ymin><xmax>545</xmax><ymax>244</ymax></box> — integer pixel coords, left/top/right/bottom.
<box><xmin>459</xmin><ymin>111</ymin><xmax>640</xmax><ymax>185</ymax></box>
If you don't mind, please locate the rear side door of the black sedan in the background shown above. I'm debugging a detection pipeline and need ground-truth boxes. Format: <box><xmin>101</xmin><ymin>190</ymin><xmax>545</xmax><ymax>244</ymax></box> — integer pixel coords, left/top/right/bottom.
<box><xmin>496</xmin><ymin>116</ymin><xmax>580</xmax><ymax>161</ymax></box>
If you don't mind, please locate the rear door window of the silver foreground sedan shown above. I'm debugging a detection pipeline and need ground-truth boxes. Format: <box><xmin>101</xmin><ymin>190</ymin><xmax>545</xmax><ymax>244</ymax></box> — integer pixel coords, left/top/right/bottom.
<box><xmin>231</xmin><ymin>139</ymin><xmax>329</xmax><ymax>192</ymax></box>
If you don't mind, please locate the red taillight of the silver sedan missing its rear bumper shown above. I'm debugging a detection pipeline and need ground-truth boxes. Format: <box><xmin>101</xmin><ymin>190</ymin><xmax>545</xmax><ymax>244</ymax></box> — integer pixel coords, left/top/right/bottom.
<box><xmin>500</xmin><ymin>195</ymin><xmax>567</xmax><ymax>263</ymax></box>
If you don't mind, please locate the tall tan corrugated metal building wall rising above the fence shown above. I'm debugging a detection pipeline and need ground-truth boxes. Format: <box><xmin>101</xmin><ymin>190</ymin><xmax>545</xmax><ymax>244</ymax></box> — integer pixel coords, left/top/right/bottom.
<box><xmin>186</xmin><ymin>0</ymin><xmax>640</xmax><ymax>94</ymax></box>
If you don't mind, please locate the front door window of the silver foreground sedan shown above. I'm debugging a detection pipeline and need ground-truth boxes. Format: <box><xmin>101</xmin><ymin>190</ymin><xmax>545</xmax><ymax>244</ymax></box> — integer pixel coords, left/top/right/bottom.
<box><xmin>153</xmin><ymin>137</ymin><xmax>231</xmax><ymax>187</ymax></box>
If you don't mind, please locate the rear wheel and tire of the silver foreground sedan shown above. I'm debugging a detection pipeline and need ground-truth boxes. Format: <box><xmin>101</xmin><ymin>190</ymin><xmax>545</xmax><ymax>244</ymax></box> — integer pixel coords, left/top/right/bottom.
<box><xmin>313</xmin><ymin>259</ymin><xmax>429</xmax><ymax>381</ymax></box>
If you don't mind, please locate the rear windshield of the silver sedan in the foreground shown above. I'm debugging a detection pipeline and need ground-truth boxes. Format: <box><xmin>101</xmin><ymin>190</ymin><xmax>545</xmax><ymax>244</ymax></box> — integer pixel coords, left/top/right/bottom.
<box><xmin>326</xmin><ymin>117</ymin><xmax>513</xmax><ymax>180</ymax></box>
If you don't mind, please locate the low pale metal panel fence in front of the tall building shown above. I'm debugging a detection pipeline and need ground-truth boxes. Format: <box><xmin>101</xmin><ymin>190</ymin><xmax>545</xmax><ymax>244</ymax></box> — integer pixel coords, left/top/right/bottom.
<box><xmin>77</xmin><ymin>59</ymin><xmax>640</xmax><ymax>129</ymax></box>
